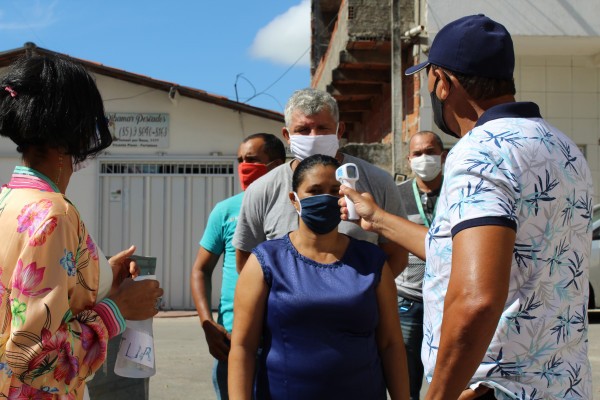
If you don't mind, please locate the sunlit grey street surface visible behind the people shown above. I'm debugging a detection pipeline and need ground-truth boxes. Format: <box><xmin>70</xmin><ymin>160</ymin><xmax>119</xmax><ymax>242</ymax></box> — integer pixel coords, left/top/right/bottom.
<box><xmin>144</xmin><ymin>311</ymin><xmax>600</xmax><ymax>400</ymax></box>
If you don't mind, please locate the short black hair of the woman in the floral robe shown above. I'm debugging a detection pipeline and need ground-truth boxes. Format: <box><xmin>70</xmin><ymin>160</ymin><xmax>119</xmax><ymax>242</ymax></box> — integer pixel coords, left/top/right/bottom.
<box><xmin>0</xmin><ymin>54</ymin><xmax>112</xmax><ymax>161</ymax></box>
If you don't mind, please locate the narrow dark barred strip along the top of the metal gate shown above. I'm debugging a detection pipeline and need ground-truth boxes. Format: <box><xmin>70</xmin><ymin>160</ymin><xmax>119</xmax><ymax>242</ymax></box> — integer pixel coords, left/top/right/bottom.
<box><xmin>100</xmin><ymin>162</ymin><xmax>234</xmax><ymax>175</ymax></box>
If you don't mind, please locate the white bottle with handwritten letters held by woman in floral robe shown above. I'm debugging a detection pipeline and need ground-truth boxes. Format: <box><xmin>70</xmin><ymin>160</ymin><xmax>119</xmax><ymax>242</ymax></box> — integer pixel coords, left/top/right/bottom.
<box><xmin>115</xmin><ymin>275</ymin><xmax>156</xmax><ymax>378</ymax></box>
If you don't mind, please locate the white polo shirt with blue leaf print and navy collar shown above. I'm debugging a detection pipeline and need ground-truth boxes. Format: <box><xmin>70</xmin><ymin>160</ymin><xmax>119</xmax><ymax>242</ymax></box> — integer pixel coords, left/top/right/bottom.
<box><xmin>422</xmin><ymin>103</ymin><xmax>593</xmax><ymax>400</ymax></box>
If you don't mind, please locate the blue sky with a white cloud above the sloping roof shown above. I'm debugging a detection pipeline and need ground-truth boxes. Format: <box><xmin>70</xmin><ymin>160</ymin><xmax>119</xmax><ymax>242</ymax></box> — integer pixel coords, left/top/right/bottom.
<box><xmin>0</xmin><ymin>0</ymin><xmax>310</xmax><ymax>112</ymax></box>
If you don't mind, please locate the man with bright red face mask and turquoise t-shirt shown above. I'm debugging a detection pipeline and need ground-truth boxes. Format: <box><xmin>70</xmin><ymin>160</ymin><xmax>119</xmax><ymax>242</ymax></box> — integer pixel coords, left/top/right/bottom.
<box><xmin>191</xmin><ymin>133</ymin><xmax>285</xmax><ymax>399</ymax></box>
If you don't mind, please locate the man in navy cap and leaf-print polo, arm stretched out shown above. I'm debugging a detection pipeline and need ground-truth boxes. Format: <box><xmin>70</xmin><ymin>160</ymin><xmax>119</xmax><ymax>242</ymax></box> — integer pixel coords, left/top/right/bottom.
<box><xmin>340</xmin><ymin>15</ymin><xmax>593</xmax><ymax>400</ymax></box>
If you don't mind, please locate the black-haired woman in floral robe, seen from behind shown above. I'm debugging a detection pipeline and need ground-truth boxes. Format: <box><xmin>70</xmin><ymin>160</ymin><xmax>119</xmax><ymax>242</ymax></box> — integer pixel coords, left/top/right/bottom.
<box><xmin>0</xmin><ymin>55</ymin><xmax>162</xmax><ymax>399</ymax></box>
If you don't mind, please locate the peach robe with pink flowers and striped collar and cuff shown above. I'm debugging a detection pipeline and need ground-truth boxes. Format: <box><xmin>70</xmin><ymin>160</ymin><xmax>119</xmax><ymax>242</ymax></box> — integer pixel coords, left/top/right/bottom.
<box><xmin>0</xmin><ymin>167</ymin><xmax>123</xmax><ymax>400</ymax></box>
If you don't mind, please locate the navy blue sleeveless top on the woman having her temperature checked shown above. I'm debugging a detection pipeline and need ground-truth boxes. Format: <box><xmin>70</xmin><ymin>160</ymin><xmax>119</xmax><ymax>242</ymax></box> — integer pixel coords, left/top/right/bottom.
<box><xmin>253</xmin><ymin>234</ymin><xmax>386</xmax><ymax>400</ymax></box>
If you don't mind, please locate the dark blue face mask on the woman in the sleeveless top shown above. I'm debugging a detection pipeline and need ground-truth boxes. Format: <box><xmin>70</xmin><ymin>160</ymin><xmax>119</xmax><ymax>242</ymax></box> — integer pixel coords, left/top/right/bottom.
<box><xmin>294</xmin><ymin>192</ymin><xmax>341</xmax><ymax>235</ymax></box>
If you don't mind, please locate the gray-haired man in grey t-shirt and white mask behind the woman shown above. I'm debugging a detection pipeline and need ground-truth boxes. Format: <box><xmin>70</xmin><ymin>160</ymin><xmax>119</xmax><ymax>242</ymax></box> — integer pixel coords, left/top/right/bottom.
<box><xmin>232</xmin><ymin>89</ymin><xmax>408</xmax><ymax>276</ymax></box>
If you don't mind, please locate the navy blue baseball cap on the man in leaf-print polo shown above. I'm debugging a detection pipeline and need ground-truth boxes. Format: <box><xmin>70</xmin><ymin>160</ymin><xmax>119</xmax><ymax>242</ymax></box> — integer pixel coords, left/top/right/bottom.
<box><xmin>405</xmin><ymin>14</ymin><xmax>515</xmax><ymax>79</ymax></box>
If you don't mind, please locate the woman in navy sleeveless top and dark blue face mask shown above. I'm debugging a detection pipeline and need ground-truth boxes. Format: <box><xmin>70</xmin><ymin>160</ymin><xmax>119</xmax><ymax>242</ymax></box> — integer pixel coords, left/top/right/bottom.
<box><xmin>229</xmin><ymin>155</ymin><xmax>409</xmax><ymax>400</ymax></box>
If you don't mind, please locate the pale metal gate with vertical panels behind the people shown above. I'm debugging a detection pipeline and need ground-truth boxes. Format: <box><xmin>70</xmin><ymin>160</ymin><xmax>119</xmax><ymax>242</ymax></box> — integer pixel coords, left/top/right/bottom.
<box><xmin>98</xmin><ymin>157</ymin><xmax>236</xmax><ymax>310</ymax></box>
